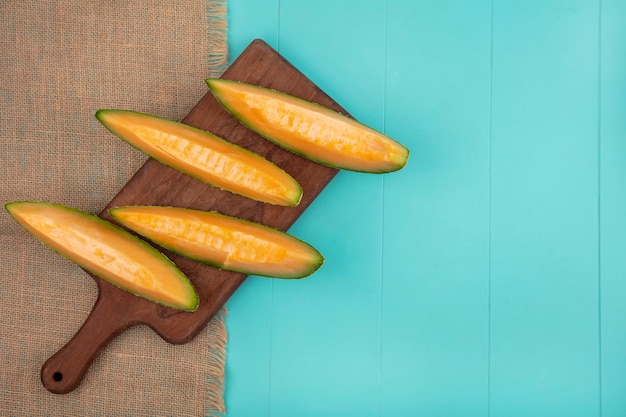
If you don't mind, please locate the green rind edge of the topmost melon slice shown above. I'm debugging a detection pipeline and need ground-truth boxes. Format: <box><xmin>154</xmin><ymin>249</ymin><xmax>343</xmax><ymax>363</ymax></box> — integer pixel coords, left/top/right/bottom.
<box><xmin>205</xmin><ymin>78</ymin><xmax>410</xmax><ymax>174</ymax></box>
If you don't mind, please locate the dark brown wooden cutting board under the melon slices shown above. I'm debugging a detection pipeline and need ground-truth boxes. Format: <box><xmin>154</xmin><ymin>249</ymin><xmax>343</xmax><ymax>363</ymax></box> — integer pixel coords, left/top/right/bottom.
<box><xmin>41</xmin><ymin>40</ymin><xmax>347</xmax><ymax>394</ymax></box>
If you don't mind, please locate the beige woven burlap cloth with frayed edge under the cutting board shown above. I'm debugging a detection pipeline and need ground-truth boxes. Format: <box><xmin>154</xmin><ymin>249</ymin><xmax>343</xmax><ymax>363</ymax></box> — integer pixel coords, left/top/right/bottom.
<box><xmin>0</xmin><ymin>0</ymin><xmax>227</xmax><ymax>416</ymax></box>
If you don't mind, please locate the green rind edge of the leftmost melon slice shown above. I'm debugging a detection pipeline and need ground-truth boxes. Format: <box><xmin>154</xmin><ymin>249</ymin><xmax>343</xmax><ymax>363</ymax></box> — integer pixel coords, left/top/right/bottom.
<box><xmin>4</xmin><ymin>201</ymin><xmax>200</xmax><ymax>312</ymax></box>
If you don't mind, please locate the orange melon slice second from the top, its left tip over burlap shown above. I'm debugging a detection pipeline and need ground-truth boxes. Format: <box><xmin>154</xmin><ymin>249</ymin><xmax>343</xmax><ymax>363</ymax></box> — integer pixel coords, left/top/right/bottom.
<box><xmin>96</xmin><ymin>110</ymin><xmax>302</xmax><ymax>206</ymax></box>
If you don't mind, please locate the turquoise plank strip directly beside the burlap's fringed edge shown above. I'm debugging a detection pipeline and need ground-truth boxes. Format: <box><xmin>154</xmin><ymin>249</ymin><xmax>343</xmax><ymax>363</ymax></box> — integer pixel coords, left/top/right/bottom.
<box><xmin>224</xmin><ymin>0</ymin><xmax>278</xmax><ymax>417</ymax></box>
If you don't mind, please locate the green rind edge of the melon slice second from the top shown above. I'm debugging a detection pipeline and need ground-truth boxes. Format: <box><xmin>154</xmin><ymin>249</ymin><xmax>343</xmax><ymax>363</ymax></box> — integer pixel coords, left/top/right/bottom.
<box><xmin>95</xmin><ymin>109</ymin><xmax>303</xmax><ymax>207</ymax></box>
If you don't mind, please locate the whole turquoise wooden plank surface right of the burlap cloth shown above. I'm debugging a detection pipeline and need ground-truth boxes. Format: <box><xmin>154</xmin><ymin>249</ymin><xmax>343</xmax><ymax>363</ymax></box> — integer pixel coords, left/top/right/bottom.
<box><xmin>226</xmin><ymin>0</ymin><xmax>626</xmax><ymax>417</ymax></box>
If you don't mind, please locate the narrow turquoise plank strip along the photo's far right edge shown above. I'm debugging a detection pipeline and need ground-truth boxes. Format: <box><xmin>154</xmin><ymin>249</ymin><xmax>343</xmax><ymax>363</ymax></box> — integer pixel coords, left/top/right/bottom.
<box><xmin>600</xmin><ymin>0</ymin><xmax>626</xmax><ymax>417</ymax></box>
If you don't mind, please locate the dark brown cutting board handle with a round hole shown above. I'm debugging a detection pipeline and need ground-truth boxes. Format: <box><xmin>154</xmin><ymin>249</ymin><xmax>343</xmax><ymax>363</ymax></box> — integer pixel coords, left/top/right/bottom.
<box><xmin>41</xmin><ymin>293</ymin><xmax>133</xmax><ymax>394</ymax></box>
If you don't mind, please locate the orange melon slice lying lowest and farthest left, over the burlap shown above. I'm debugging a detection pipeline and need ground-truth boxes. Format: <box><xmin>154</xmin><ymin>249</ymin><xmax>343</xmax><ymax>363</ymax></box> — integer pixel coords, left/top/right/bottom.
<box><xmin>6</xmin><ymin>202</ymin><xmax>198</xmax><ymax>311</ymax></box>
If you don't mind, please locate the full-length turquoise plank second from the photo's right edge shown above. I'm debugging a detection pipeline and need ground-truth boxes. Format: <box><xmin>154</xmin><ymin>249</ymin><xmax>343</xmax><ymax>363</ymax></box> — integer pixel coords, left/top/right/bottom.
<box><xmin>490</xmin><ymin>0</ymin><xmax>600</xmax><ymax>417</ymax></box>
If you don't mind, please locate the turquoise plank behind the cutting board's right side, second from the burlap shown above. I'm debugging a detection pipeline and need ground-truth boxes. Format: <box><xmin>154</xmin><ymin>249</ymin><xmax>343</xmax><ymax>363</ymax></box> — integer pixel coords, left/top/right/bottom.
<box><xmin>270</xmin><ymin>0</ymin><xmax>385</xmax><ymax>416</ymax></box>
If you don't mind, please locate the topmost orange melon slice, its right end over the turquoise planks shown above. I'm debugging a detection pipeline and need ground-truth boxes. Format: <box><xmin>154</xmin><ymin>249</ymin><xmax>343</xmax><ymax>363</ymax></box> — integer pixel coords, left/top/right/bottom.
<box><xmin>206</xmin><ymin>79</ymin><xmax>409</xmax><ymax>173</ymax></box>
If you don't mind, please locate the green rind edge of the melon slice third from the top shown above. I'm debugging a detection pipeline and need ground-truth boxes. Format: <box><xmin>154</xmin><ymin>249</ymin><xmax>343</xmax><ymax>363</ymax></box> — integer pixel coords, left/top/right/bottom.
<box><xmin>109</xmin><ymin>206</ymin><xmax>325</xmax><ymax>279</ymax></box>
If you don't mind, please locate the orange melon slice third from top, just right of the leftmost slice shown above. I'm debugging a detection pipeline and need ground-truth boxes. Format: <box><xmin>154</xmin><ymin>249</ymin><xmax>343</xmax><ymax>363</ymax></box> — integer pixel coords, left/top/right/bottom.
<box><xmin>109</xmin><ymin>206</ymin><xmax>324</xmax><ymax>278</ymax></box>
